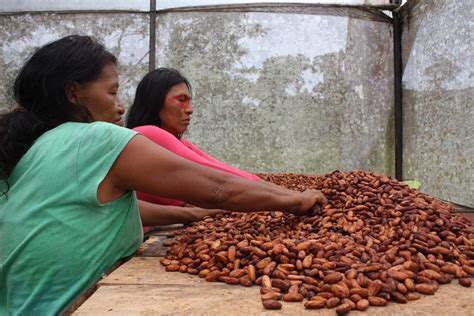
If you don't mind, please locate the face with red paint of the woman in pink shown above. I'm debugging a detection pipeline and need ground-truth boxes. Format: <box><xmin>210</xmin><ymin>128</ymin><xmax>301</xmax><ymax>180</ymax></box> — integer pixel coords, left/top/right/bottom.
<box><xmin>159</xmin><ymin>82</ymin><xmax>193</xmax><ymax>137</ymax></box>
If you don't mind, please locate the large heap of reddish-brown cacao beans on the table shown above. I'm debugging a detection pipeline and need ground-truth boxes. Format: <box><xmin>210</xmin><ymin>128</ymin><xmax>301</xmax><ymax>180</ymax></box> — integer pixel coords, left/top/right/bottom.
<box><xmin>161</xmin><ymin>171</ymin><xmax>474</xmax><ymax>314</ymax></box>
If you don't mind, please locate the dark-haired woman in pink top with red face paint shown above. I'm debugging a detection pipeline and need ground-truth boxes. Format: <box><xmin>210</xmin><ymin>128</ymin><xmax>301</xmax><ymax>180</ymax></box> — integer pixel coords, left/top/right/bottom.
<box><xmin>127</xmin><ymin>68</ymin><xmax>259</xmax><ymax>224</ymax></box>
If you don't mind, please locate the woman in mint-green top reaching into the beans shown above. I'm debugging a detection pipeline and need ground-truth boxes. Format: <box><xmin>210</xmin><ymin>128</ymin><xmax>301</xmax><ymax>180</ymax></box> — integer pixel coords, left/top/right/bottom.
<box><xmin>0</xmin><ymin>35</ymin><xmax>325</xmax><ymax>315</ymax></box>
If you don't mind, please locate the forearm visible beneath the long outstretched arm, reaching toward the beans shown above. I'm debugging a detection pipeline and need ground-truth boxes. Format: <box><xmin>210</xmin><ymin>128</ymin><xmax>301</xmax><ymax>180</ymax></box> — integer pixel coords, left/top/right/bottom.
<box><xmin>138</xmin><ymin>200</ymin><xmax>228</xmax><ymax>226</ymax></box>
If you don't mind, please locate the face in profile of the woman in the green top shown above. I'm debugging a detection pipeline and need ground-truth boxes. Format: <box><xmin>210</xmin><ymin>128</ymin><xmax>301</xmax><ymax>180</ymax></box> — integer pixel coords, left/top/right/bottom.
<box><xmin>70</xmin><ymin>63</ymin><xmax>125</xmax><ymax>126</ymax></box>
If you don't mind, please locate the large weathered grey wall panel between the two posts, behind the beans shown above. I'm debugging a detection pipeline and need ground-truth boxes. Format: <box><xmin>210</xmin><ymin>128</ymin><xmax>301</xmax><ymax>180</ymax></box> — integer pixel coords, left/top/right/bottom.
<box><xmin>157</xmin><ymin>9</ymin><xmax>394</xmax><ymax>174</ymax></box>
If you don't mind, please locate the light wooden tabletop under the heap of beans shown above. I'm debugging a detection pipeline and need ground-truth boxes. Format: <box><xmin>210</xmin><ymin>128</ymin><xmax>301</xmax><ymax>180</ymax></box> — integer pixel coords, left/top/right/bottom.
<box><xmin>74</xmin><ymin>223</ymin><xmax>474</xmax><ymax>316</ymax></box>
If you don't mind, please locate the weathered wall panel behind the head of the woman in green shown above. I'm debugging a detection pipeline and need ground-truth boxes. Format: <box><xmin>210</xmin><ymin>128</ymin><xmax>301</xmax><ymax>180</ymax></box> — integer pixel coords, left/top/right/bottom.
<box><xmin>0</xmin><ymin>13</ymin><xmax>150</xmax><ymax>110</ymax></box>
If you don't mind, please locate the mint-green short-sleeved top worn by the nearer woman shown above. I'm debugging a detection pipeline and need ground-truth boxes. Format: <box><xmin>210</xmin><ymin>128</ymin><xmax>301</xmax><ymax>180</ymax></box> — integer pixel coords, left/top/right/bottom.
<box><xmin>0</xmin><ymin>122</ymin><xmax>143</xmax><ymax>315</ymax></box>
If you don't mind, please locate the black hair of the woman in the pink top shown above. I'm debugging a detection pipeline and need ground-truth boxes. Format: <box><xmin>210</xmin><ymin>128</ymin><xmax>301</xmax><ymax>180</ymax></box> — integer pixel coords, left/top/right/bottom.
<box><xmin>127</xmin><ymin>68</ymin><xmax>191</xmax><ymax>128</ymax></box>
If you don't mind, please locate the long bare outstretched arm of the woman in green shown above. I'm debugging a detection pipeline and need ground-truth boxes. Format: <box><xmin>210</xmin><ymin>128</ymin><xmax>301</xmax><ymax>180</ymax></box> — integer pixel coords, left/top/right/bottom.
<box><xmin>98</xmin><ymin>135</ymin><xmax>325</xmax><ymax>214</ymax></box>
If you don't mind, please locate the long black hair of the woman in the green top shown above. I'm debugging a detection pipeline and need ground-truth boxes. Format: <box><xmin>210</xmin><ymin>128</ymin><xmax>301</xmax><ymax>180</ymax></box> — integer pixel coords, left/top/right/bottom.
<box><xmin>0</xmin><ymin>35</ymin><xmax>117</xmax><ymax>195</ymax></box>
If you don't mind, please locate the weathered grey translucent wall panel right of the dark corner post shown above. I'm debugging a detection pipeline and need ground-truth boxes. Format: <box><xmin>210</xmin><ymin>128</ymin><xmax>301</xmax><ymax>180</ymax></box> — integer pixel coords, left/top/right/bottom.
<box><xmin>402</xmin><ymin>0</ymin><xmax>474</xmax><ymax>206</ymax></box>
